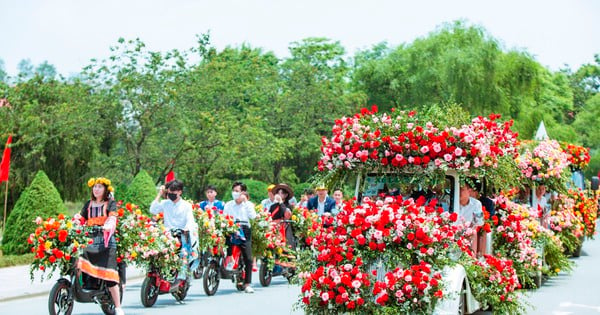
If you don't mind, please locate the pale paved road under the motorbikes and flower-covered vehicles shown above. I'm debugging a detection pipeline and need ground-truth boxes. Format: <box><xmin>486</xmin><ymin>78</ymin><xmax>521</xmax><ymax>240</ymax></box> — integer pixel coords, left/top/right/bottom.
<box><xmin>0</xmin><ymin>237</ymin><xmax>600</xmax><ymax>315</ymax></box>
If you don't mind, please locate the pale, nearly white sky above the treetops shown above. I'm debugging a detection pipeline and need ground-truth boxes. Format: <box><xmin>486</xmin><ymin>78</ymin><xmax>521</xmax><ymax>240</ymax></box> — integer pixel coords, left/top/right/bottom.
<box><xmin>0</xmin><ymin>0</ymin><xmax>600</xmax><ymax>76</ymax></box>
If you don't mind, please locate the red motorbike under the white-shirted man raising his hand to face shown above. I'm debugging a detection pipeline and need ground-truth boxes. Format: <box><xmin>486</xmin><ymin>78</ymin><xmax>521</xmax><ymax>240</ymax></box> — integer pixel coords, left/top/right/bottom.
<box><xmin>140</xmin><ymin>229</ymin><xmax>195</xmax><ymax>307</ymax></box>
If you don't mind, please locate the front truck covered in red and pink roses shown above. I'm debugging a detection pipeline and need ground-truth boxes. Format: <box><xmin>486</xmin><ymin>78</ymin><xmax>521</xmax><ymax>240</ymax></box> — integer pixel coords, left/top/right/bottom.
<box><xmin>299</xmin><ymin>107</ymin><xmax>522</xmax><ymax>314</ymax></box>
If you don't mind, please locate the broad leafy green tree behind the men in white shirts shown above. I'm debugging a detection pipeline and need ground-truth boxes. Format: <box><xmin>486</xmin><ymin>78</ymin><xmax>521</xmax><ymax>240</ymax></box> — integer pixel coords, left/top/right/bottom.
<box><xmin>176</xmin><ymin>42</ymin><xmax>280</xmax><ymax>199</ymax></box>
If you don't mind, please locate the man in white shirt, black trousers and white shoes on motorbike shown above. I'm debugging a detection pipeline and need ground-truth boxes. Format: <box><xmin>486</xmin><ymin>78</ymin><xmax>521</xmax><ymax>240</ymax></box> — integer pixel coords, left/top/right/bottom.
<box><xmin>223</xmin><ymin>182</ymin><xmax>256</xmax><ymax>293</ymax></box>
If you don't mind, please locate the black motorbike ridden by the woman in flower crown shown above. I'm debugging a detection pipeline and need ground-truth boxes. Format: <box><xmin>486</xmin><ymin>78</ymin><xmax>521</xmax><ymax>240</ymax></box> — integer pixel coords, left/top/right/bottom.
<box><xmin>48</xmin><ymin>227</ymin><xmax>126</xmax><ymax>315</ymax></box>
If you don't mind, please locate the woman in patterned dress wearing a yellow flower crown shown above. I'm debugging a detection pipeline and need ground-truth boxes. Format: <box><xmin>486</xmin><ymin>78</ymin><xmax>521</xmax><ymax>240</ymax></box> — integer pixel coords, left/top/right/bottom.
<box><xmin>77</xmin><ymin>177</ymin><xmax>124</xmax><ymax>315</ymax></box>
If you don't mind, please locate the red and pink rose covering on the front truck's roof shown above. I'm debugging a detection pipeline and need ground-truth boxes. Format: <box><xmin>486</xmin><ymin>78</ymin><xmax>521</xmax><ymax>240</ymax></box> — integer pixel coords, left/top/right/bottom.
<box><xmin>318</xmin><ymin>106</ymin><xmax>518</xmax><ymax>184</ymax></box>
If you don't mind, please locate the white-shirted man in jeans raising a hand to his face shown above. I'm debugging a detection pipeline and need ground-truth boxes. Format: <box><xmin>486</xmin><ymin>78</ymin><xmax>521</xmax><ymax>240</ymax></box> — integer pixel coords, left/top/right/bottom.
<box><xmin>150</xmin><ymin>179</ymin><xmax>198</xmax><ymax>292</ymax></box>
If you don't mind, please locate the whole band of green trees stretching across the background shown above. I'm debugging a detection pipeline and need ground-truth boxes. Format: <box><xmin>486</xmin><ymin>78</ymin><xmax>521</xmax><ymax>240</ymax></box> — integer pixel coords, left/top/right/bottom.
<box><xmin>0</xmin><ymin>21</ymin><xmax>600</xmax><ymax>215</ymax></box>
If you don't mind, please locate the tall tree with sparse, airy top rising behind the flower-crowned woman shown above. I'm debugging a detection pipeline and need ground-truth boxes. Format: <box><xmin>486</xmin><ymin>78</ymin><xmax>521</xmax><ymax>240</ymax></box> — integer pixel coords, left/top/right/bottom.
<box><xmin>84</xmin><ymin>39</ymin><xmax>186</xmax><ymax>182</ymax></box>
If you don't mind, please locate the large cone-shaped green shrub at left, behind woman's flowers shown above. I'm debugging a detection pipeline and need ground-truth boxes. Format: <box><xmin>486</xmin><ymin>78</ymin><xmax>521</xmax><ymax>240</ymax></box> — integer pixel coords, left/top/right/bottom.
<box><xmin>2</xmin><ymin>171</ymin><xmax>67</xmax><ymax>255</ymax></box>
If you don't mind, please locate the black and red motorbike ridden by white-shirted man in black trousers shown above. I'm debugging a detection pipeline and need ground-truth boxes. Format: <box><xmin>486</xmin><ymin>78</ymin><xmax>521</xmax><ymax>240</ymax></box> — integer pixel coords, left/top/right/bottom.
<box><xmin>202</xmin><ymin>232</ymin><xmax>246</xmax><ymax>296</ymax></box>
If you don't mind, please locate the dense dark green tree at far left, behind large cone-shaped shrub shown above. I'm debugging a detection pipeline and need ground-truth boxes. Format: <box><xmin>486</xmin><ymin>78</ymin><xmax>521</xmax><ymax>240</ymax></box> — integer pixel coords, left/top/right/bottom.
<box><xmin>0</xmin><ymin>76</ymin><xmax>108</xmax><ymax>200</ymax></box>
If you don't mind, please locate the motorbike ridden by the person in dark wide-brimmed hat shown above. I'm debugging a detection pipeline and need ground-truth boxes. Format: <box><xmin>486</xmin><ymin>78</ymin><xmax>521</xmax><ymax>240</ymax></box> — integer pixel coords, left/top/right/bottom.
<box><xmin>258</xmin><ymin>220</ymin><xmax>296</xmax><ymax>287</ymax></box>
